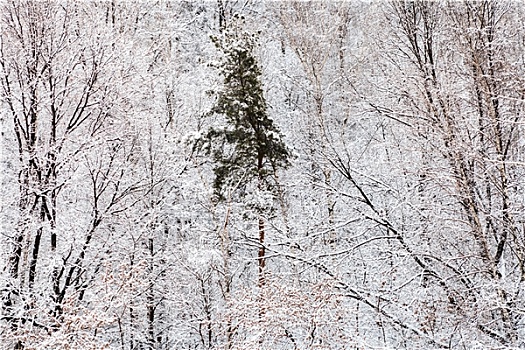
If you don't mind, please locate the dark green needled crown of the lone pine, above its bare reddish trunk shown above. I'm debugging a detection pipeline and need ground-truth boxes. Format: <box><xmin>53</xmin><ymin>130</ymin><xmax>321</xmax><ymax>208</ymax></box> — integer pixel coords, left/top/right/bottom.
<box><xmin>202</xmin><ymin>22</ymin><xmax>290</xmax><ymax>198</ymax></box>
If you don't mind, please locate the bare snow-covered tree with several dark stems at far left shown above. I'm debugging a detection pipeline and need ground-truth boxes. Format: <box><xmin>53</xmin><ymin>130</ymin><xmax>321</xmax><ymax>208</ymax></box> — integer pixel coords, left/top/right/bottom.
<box><xmin>0</xmin><ymin>1</ymin><xmax>133</xmax><ymax>348</ymax></box>
